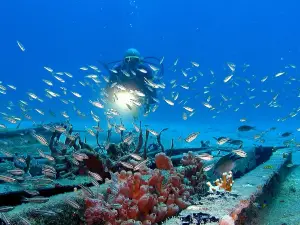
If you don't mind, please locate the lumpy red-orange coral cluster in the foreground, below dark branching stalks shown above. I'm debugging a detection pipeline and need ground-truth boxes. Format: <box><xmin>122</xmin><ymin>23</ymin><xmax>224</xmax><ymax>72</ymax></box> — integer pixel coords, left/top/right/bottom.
<box><xmin>85</xmin><ymin>154</ymin><xmax>199</xmax><ymax>225</ymax></box>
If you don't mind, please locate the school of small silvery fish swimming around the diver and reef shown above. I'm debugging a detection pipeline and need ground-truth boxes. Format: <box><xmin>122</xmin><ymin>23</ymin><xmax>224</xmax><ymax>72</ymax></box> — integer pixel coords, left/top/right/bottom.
<box><xmin>0</xmin><ymin>41</ymin><xmax>300</xmax><ymax>224</ymax></box>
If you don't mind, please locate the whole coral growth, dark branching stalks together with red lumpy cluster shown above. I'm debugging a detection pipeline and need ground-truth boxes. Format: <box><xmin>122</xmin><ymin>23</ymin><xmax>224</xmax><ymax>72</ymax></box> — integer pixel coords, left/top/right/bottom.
<box><xmin>0</xmin><ymin>123</ymin><xmax>211</xmax><ymax>225</ymax></box>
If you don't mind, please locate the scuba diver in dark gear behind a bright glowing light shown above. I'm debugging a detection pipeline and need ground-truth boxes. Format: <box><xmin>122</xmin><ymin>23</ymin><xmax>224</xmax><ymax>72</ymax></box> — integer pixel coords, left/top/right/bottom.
<box><xmin>100</xmin><ymin>48</ymin><xmax>163</xmax><ymax>113</ymax></box>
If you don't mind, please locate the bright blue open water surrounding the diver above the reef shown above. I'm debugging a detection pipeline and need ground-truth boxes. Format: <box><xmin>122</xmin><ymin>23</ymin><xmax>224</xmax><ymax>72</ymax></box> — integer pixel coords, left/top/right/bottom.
<box><xmin>0</xmin><ymin>0</ymin><xmax>300</xmax><ymax>223</ymax></box>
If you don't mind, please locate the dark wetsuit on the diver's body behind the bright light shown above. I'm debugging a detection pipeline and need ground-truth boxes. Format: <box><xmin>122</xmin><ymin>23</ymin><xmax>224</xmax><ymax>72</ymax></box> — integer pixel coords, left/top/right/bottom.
<box><xmin>107</xmin><ymin>63</ymin><xmax>156</xmax><ymax>111</ymax></box>
